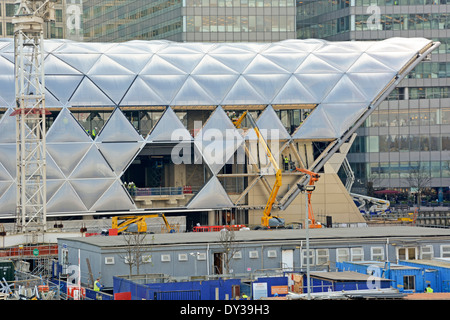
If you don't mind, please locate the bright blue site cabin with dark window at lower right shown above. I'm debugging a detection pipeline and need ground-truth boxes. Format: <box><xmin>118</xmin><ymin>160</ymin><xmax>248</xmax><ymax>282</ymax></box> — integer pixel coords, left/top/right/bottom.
<box><xmin>336</xmin><ymin>261</ymin><xmax>426</xmax><ymax>293</ymax></box>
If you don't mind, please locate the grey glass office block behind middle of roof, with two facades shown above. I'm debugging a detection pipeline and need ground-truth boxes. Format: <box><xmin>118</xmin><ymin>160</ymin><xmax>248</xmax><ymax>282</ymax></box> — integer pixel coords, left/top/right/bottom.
<box><xmin>83</xmin><ymin>0</ymin><xmax>296</xmax><ymax>42</ymax></box>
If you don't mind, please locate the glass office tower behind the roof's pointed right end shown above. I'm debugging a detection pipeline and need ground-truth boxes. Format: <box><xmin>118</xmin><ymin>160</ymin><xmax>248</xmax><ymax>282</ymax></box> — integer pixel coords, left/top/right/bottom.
<box><xmin>297</xmin><ymin>0</ymin><xmax>450</xmax><ymax>201</ymax></box>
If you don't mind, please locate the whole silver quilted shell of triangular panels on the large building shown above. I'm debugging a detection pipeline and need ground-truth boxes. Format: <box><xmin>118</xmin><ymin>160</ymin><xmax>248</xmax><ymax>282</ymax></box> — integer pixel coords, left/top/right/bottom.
<box><xmin>0</xmin><ymin>38</ymin><xmax>435</xmax><ymax>216</ymax></box>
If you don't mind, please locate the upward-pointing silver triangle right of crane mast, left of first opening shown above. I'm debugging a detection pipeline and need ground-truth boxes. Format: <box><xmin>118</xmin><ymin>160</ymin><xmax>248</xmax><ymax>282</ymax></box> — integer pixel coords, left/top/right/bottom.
<box><xmin>46</xmin><ymin>108</ymin><xmax>92</xmax><ymax>143</ymax></box>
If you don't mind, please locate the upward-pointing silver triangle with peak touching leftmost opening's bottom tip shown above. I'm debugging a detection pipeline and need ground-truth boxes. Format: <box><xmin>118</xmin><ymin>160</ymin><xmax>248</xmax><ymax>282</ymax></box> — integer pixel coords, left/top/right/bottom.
<box><xmin>70</xmin><ymin>145</ymin><xmax>115</xmax><ymax>179</ymax></box>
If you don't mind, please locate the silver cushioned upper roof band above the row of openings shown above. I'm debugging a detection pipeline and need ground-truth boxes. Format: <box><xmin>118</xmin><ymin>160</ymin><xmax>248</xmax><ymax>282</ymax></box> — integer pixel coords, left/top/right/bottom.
<box><xmin>0</xmin><ymin>38</ymin><xmax>431</xmax><ymax>107</ymax></box>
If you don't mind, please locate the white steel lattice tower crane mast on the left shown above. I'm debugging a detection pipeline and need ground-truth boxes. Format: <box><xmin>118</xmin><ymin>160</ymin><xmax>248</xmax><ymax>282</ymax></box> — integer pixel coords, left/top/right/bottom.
<box><xmin>11</xmin><ymin>0</ymin><xmax>56</xmax><ymax>232</ymax></box>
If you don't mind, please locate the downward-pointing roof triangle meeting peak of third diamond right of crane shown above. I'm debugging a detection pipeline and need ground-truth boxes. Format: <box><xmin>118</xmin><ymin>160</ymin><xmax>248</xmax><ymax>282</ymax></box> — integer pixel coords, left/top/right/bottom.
<box><xmin>139</xmin><ymin>75</ymin><xmax>187</xmax><ymax>105</ymax></box>
